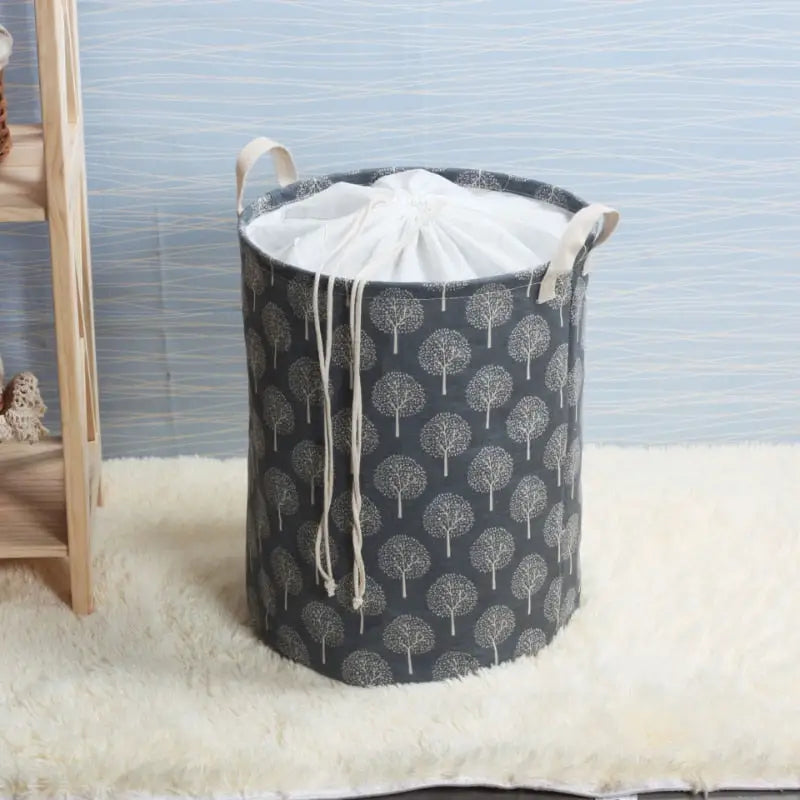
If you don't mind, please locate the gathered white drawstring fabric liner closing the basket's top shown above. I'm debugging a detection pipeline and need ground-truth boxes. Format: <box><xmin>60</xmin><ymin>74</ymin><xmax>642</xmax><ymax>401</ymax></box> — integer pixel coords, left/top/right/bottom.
<box><xmin>245</xmin><ymin>169</ymin><xmax>572</xmax><ymax>283</ymax></box>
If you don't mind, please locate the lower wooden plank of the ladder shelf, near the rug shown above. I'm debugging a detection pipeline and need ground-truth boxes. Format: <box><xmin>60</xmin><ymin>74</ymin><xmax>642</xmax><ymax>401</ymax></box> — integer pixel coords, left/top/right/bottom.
<box><xmin>0</xmin><ymin>439</ymin><xmax>67</xmax><ymax>558</ymax></box>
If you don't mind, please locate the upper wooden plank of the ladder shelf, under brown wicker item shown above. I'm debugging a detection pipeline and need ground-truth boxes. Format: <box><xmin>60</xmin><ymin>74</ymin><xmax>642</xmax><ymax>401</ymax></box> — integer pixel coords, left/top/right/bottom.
<box><xmin>0</xmin><ymin>125</ymin><xmax>47</xmax><ymax>222</ymax></box>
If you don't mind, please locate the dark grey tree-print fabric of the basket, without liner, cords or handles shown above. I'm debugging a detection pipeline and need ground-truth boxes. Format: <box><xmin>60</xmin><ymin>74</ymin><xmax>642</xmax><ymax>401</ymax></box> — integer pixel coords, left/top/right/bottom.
<box><xmin>240</xmin><ymin>170</ymin><xmax>592</xmax><ymax>685</ymax></box>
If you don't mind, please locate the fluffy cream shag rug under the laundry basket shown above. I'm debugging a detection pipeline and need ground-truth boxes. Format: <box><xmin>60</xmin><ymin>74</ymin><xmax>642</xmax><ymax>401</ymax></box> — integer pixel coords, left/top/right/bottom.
<box><xmin>0</xmin><ymin>446</ymin><xmax>800</xmax><ymax>798</ymax></box>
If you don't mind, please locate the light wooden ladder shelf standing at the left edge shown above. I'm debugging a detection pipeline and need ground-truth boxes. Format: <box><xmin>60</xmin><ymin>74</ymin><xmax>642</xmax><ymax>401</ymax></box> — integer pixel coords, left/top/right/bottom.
<box><xmin>0</xmin><ymin>0</ymin><xmax>102</xmax><ymax>614</ymax></box>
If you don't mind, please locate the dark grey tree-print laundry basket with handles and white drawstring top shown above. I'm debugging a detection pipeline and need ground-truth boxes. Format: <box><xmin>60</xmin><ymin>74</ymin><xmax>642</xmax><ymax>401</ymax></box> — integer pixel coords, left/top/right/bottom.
<box><xmin>237</xmin><ymin>138</ymin><xmax>618</xmax><ymax>686</ymax></box>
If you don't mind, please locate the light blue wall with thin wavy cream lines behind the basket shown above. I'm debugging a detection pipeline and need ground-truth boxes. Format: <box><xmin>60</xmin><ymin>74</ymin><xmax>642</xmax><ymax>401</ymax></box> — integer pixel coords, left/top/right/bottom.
<box><xmin>0</xmin><ymin>0</ymin><xmax>800</xmax><ymax>456</ymax></box>
